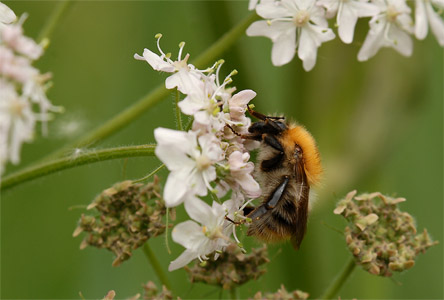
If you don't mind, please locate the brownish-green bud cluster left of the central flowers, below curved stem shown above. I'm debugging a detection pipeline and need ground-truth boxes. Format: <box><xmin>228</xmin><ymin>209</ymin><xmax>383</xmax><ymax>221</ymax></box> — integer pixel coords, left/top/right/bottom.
<box><xmin>73</xmin><ymin>177</ymin><xmax>172</xmax><ymax>266</ymax></box>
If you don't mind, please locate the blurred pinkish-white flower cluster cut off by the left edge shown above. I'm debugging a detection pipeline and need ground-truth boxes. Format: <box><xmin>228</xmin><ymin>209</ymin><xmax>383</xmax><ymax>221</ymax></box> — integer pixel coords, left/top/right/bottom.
<box><xmin>0</xmin><ymin>3</ymin><xmax>59</xmax><ymax>176</ymax></box>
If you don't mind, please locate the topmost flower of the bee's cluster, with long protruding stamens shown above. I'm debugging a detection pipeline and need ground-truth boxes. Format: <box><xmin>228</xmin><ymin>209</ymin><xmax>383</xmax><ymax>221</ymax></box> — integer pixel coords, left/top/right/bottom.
<box><xmin>134</xmin><ymin>34</ymin><xmax>202</xmax><ymax>94</ymax></box>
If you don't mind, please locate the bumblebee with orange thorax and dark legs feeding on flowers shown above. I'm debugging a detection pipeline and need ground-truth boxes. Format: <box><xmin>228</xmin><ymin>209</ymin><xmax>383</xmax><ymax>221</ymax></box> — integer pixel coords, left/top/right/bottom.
<box><xmin>234</xmin><ymin>107</ymin><xmax>322</xmax><ymax>250</ymax></box>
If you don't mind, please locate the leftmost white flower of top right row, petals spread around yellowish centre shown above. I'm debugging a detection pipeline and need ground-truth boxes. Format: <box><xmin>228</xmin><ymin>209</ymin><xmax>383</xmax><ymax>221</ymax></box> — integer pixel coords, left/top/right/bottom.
<box><xmin>247</xmin><ymin>0</ymin><xmax>335</xmax><ymax>71</ymax></box>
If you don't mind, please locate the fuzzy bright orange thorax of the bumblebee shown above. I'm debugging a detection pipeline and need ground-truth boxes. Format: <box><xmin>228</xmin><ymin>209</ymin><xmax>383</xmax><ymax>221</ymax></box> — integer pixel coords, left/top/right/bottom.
<box><xmin>280</xmin><ymin>125</ymin><xmax>322</xmax><ymax>185</ymax></box>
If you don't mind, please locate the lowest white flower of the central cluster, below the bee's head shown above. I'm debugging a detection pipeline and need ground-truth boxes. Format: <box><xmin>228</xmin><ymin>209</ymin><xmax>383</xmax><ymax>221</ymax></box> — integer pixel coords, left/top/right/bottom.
<box><xmin>168</xmin><ymin>198</ymin><xmax>231</xmax><ymax>271</ymax></box>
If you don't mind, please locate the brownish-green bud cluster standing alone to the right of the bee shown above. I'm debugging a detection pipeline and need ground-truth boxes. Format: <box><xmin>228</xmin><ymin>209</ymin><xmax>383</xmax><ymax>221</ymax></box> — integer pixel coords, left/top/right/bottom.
<box><xmin>334</xmin><ymin>191</ymin><xmax>437</xmax><ymax>276</ymax></box>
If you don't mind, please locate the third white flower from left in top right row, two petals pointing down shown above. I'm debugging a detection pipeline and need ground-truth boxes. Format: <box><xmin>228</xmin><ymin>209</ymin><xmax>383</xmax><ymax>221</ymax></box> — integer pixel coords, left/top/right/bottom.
<box><xmin>358</xmin><ymin>0</ymin><xmax>413</xmax><ymax>61</ymax></box>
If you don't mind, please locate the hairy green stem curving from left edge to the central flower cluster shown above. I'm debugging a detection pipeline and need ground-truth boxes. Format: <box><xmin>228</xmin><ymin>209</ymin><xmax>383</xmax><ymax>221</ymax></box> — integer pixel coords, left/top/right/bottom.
<box><xmin>1</xmin><ymin>145</ymin><xmax>156</xmax><ymax>191</ymax></box>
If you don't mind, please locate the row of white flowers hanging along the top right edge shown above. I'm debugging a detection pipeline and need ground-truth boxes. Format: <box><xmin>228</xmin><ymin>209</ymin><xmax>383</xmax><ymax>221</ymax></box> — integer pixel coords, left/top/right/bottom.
<box><xmin>247</xmin><ymin>0</ymin><xmax>444</xmax><ymax>71</ymax></box>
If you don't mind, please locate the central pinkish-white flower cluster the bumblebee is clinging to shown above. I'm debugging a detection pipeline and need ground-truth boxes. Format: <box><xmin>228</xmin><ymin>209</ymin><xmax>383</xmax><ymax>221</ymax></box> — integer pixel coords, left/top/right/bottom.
<box><xmin>134</xmin><ymin>34</ymin><xmax>261</xmax><ymax>271</ymax></box>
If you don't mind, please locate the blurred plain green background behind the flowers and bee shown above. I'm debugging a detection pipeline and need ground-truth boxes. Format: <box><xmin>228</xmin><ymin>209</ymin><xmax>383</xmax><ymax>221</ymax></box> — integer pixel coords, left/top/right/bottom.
<box><xmin>1</xmin><ymin>1</ymin><xmax>444</xmax><ymax>299</ymax></box>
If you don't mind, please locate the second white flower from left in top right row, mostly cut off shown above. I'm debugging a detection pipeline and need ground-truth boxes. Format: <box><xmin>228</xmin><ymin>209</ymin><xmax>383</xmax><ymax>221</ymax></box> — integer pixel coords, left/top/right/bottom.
<box><xmin>317</xmin><ymin>0</ymin><xmax>379</xmax><ymax>44</ymax></box>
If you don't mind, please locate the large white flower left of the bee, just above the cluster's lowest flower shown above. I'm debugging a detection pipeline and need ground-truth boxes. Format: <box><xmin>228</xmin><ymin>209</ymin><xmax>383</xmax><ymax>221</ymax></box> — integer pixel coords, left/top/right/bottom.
<box><xmin>154</xmin><ymin>128</ymin><xmax>224</xmax><ymax>207</ymax></box>
